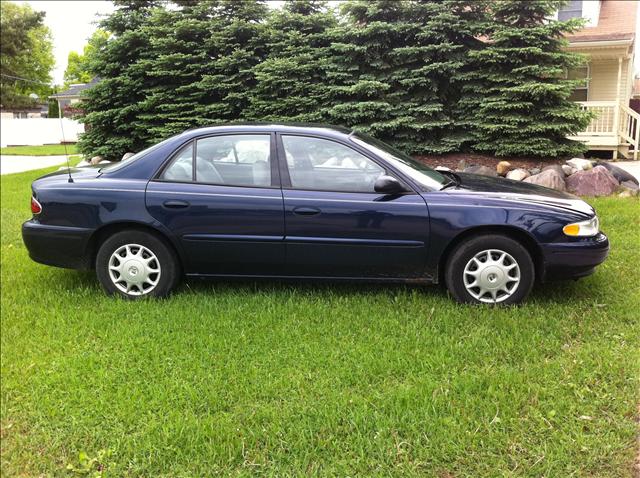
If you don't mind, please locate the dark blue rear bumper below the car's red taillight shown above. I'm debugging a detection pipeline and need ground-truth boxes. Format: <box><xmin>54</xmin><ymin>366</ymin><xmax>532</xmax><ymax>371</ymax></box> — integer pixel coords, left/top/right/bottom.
<box><xmin>22</xmin><ymin>219</ymin><xmax>93</xmax><ymax>269</ymax></box>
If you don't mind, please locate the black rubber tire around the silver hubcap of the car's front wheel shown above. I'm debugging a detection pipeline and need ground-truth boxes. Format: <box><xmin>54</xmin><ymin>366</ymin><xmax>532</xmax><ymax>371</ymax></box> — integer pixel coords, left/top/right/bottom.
<box><xmin>444</xmin><ymin>234</ymin><xmax>535</xmax><ymax>305</ymax></box>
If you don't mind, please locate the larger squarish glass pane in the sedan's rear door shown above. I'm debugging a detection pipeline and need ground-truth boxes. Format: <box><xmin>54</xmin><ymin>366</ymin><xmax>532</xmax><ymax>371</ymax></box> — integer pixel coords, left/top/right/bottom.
<box><xmin>195</xmin><ymin>134</ymin><xmax>271</xmax><ymax>187</ymax></box>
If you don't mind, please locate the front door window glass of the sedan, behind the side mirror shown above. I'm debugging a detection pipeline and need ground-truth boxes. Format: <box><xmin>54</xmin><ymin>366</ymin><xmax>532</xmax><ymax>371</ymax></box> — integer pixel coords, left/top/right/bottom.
<box><xmin>282</xmin><ymin>135</ymin><xmax>384</xmax><ymax>193</ymax></box>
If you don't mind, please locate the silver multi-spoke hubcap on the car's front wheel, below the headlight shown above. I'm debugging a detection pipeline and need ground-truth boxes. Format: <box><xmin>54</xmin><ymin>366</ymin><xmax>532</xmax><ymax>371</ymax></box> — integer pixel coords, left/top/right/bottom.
<box><xmin>463</xmin><ymin>249</ymin><xmax>520</xmax><ymax>303</ymax></box>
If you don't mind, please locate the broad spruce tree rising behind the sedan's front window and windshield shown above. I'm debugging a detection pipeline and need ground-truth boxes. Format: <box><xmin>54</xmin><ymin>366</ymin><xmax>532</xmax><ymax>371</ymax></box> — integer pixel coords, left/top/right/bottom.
<box><xmin>325</xmin><ymin>0</ymin><xmax>477</xmax><ymax>154</ymax></box>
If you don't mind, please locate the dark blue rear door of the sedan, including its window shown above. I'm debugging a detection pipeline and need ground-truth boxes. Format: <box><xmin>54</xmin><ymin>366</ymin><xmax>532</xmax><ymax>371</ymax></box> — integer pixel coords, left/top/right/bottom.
<box><xmin>146</xmin><ymin>133</ymin><xmax>285</xmax><ymax>275</ymax></box>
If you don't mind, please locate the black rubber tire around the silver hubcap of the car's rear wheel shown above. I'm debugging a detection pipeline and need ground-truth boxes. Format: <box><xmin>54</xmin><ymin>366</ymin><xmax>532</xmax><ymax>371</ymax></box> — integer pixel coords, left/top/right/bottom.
<box><xmin>96</xmin><ymin>230</ymin><xmax>181</xmax><ymax>299</ymax></box>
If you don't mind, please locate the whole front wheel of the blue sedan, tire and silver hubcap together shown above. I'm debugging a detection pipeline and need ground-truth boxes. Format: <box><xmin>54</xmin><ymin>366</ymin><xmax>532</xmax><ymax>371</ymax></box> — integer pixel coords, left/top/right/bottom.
<box><xmin>445</xmin><ymin>235</ymin><xmax>535</xmax><ymax>305</ymax></box>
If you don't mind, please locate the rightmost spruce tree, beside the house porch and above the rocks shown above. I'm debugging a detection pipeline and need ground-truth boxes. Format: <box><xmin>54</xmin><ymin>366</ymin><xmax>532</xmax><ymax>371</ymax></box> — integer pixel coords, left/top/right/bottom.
<box><xmin>466</xmin><ymin>0</ymin><xmax>590</xmax><ymax>157</ymax></box>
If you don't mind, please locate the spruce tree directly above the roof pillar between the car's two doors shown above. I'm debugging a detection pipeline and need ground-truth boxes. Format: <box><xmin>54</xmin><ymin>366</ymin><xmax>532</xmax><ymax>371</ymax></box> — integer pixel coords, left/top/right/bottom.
<box><xmin>245</xmin><ymin>0</ymin><xmax>336</xmax><ymax>122</ymax></box>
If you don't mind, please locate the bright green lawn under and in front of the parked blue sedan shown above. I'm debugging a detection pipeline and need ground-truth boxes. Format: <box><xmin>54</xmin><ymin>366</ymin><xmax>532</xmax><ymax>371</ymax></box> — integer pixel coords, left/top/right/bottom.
<box><xmin>1</xmin><ymin>166</ymin><xmax>640</xmax><ymax>477</ymax></box>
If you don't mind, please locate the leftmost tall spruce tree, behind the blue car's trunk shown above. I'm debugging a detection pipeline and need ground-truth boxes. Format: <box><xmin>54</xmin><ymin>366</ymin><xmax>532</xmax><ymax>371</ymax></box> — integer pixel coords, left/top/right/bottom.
<box><xmin>79</xmin><ymin>0</ymin><xmax>159</xmax><ymax>160</ymax></box>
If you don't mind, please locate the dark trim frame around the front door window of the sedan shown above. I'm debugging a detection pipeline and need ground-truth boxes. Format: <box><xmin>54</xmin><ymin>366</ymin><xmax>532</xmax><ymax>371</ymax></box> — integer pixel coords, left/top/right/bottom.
<box><xmin>276</xmin><ymin>131</ymin><xmax>418</xmax><ymax>195</ymax></box>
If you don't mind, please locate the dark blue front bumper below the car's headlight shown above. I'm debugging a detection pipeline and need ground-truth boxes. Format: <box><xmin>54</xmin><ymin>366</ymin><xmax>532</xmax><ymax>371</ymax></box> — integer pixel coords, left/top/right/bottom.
<box><xmin>541</xmin><ymin>233</ymin><xmax>609</xmax><ymax>282</ymax></box>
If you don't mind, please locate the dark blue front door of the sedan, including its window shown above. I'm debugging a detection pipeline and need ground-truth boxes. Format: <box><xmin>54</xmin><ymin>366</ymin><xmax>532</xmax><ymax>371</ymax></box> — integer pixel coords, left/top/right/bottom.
<box><xmin>278</xmin><ymin>134</ymin><xmax>429</xmax><ymax>278</ymax></box>
